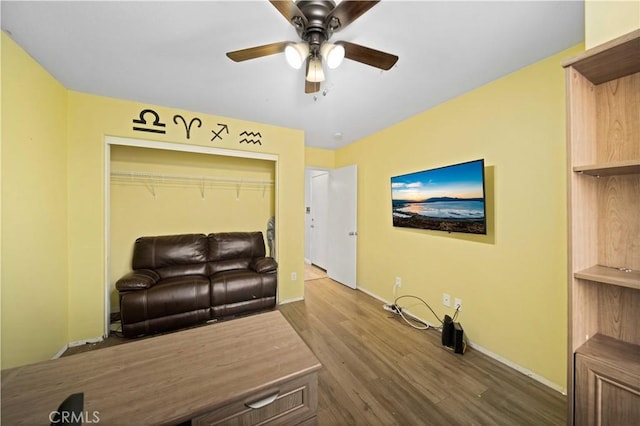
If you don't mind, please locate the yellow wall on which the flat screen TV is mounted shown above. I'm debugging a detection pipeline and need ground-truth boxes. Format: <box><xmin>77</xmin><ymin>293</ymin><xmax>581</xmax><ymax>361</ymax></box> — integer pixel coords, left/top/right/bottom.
<box><xmin>336</xmin><ymin>46</ymin><xmax>582</xmax><ymax>387</ymax></box>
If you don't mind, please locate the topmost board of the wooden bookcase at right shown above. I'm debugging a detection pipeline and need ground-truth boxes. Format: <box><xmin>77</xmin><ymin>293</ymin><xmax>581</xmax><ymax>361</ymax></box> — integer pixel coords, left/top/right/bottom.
<box><xmin>562</xmin><ymin>30</ymin><xmax>640</xmax><ymax>84</ymax></box>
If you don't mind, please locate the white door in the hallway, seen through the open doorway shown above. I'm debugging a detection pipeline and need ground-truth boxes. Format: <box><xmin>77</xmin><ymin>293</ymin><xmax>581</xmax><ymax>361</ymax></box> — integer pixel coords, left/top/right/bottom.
<box><xmin>309</xmin><ymin>172</ymin><xmax>329</xmax><ymax>270</ymax></box>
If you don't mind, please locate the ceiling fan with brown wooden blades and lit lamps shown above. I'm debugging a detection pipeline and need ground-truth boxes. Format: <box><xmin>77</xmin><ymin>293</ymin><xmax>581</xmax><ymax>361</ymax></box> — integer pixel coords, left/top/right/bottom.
<box><xmin>227</xmin><ymin>0</ymin><xmax>398</xmax><ymax>93</ymax></box>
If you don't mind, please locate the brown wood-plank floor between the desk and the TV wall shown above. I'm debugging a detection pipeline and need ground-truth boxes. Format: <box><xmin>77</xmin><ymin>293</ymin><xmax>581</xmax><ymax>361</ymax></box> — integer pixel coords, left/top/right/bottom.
<box><xmin>279</xmin><ymin>278</ymin><xmax>566</xmax><ymax>425</ymax></box>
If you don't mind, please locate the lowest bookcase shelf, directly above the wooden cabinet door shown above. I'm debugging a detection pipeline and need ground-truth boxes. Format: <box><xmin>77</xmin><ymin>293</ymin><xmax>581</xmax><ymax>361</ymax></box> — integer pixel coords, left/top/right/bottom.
<box><xmin>576</xmin><ymin>334</ymin><xmax>640</xmax><ymax>376</ymax></box>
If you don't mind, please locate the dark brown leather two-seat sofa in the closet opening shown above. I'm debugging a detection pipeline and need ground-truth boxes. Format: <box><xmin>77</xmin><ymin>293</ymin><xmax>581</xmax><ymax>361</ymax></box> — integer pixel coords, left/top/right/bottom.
<box><xmin>116</xmin><ymin>232</ymin><xmax>277</xmax><ymax>337</ymax></box>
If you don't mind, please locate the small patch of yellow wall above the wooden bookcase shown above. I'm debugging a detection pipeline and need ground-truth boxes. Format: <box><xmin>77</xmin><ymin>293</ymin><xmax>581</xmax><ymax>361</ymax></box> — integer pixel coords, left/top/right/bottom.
<box><xmin>584</xmin><ymin>0</ymin><xmax>640</xmax><ymax>49</ymax></box>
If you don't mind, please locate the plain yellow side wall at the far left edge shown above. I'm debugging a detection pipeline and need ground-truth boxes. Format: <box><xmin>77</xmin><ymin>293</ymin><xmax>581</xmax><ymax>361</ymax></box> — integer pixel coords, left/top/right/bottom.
<box><xmin>1</xmin><ymin>33</ymin><xmax>68</xmax><ymax>368</ymax></box>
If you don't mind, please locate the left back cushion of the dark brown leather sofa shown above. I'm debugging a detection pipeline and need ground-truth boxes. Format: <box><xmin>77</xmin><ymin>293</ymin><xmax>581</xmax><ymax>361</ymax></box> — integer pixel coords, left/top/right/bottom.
<box><xmin>132</xmin><ymin>234</ymin><xmax>208</xmax><ymax>279</ymax></box>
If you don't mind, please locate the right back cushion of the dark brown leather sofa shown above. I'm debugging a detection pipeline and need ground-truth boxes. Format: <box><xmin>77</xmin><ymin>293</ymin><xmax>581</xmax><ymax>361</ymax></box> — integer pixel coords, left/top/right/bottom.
<box><xmin>208</xmin><ymin>232</ymin><xmax>265</xmax><ymax>274</ymax></box>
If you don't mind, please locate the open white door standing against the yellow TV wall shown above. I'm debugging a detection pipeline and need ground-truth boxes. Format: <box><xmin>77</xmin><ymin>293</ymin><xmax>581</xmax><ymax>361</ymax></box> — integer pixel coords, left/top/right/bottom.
<box><xmin>327</xmin><ymin>165</ymin><xmax>358</xmax><ymax>288</ymax></box>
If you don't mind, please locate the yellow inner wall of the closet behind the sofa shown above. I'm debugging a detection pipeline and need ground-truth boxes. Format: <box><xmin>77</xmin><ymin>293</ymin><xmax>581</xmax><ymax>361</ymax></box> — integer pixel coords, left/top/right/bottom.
<box><xmin>109</xmin><ymin>145</ymin><xmax>275</xmax><ymax>312</ymax></box>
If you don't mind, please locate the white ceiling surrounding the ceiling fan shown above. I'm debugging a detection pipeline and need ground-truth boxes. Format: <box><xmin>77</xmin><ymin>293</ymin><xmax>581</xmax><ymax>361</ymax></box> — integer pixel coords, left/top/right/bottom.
<box><xmin>1</xmin><ymin>0</ymin><xmax>584</xmax><ymax>149</ymax></box>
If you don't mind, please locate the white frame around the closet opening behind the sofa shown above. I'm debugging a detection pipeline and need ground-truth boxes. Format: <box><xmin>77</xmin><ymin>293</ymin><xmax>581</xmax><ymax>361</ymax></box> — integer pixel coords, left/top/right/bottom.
<box><xmin>103</xmin><ymin>136</ymin><xmax>280</xmax><ymax>337</ymax></box>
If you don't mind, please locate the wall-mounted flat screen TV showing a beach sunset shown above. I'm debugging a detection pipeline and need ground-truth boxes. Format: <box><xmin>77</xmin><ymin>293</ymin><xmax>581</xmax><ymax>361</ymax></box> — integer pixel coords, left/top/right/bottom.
<box><xmin>391</xmin><ymin>159</ymin><xmax>487</xmax><ymax>234</ymax></box>
